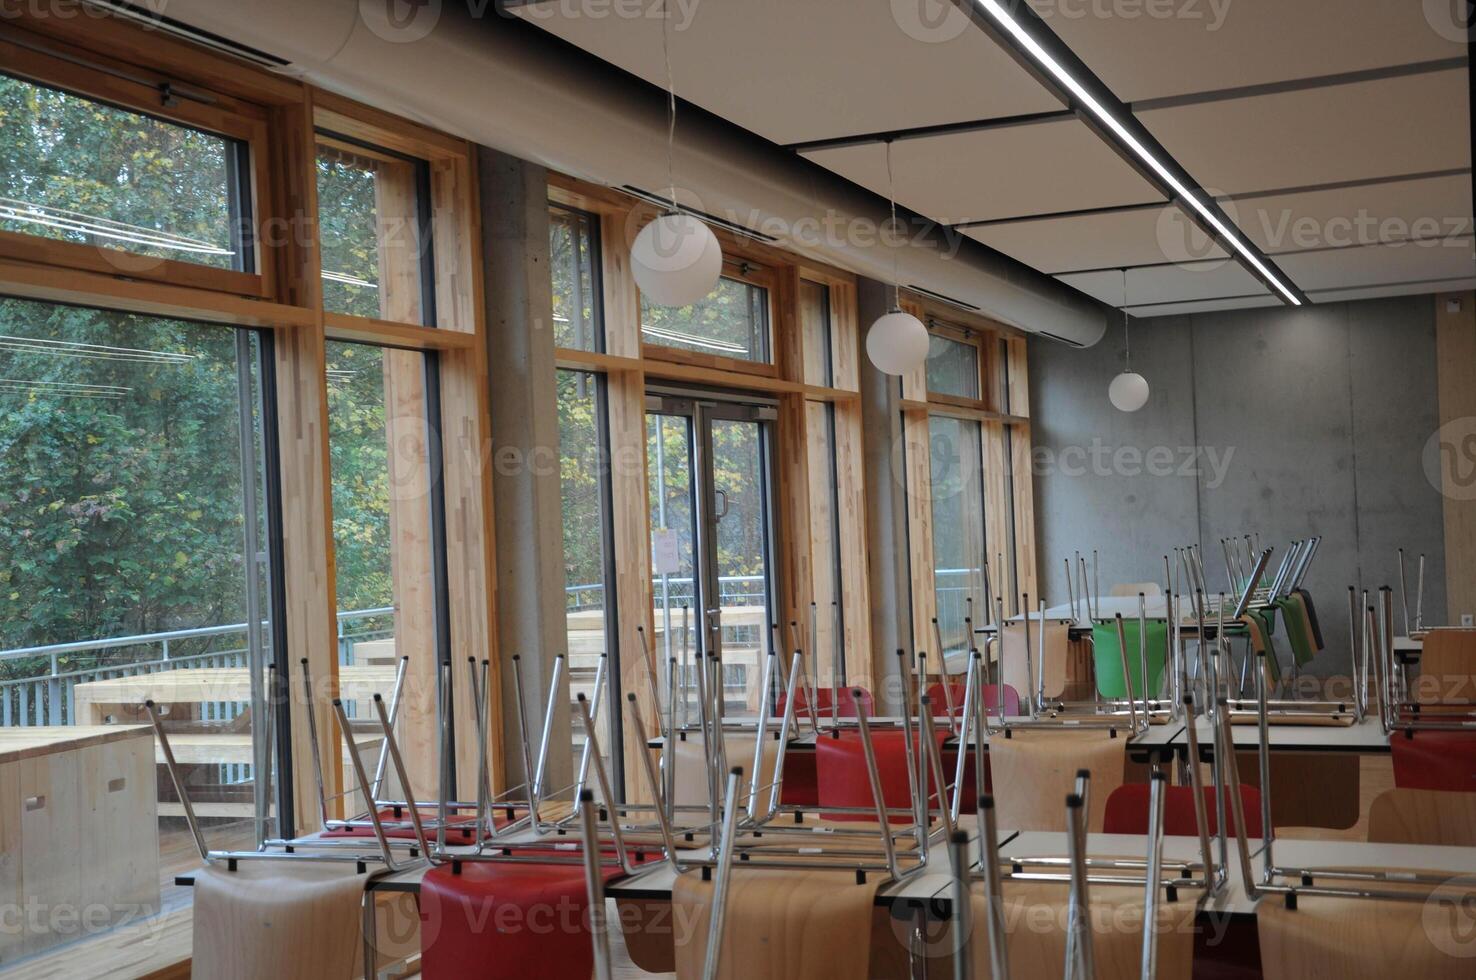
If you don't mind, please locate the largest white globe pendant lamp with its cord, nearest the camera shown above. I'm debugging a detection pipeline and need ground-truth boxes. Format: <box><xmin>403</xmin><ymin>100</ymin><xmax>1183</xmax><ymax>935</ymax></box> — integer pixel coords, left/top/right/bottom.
<box><xmin>630</xmin><ymin>0</ymin><xmax>723</xmax><ymax>307</ymax></box>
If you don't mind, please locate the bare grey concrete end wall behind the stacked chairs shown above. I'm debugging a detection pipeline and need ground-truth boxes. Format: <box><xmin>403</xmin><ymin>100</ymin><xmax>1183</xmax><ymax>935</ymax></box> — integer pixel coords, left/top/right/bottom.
<box><xmin>1030</xmin><ymin>297</ymin><xmax>1446</xmax><ymax>673</ymax></box>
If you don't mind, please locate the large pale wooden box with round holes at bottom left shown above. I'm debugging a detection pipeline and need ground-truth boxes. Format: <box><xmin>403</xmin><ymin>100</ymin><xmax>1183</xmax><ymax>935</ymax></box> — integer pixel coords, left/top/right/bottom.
<box><xmin>0</xmin><ymin>725</ymin><xmax>159</xmax><ymax>964</ymax></box>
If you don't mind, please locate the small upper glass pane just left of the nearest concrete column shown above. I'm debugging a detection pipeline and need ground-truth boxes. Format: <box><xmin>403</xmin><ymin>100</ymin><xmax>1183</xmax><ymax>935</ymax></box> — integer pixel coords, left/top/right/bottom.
<box><xmin>317</xmin><ymin>142</ymin><xmax>430</xmax><ymax>323</ymax></box>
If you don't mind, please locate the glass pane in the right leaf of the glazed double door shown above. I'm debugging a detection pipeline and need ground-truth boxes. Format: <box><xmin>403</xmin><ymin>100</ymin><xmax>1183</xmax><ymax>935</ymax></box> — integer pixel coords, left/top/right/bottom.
<box><xmin>711</xmin><ymin>419</ymin><xmax>779</xmax><ymax>714</ymax></box>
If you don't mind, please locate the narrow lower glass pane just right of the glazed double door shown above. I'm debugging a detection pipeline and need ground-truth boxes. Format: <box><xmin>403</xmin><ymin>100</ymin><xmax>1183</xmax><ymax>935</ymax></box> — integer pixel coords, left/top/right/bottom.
<box><xmin>804</xmin><ymin>401</ymin><xmax>846</xmax><ymax>688</ymax></box>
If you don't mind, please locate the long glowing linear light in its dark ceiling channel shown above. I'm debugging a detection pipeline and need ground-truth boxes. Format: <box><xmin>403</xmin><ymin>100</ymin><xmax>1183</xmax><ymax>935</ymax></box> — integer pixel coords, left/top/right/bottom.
<box><xmin>953</xmin><ymin>0</ymin><xmax>1303</xmax><ymax>306</ymax></box>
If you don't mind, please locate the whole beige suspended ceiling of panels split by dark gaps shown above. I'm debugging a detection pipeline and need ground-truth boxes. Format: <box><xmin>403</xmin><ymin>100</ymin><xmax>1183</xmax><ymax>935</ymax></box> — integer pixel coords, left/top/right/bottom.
<box><xmin>515</xmin><ymin>0</ymin><xmax>1476</xmax><ymax>316</ymax></box>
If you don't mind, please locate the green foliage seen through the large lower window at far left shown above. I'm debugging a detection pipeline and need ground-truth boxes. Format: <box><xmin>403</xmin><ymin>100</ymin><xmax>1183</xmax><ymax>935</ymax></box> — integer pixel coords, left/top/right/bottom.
<box><xmin>0</xmin><ymin>300</ymin><xmax>254</xmax><ymax>678</ymax></box>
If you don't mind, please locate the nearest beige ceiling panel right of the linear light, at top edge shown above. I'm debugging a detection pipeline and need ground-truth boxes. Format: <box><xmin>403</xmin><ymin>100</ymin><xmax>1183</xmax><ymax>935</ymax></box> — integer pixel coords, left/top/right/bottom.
<box><xmin>1030</xmin><ymin>0</ymin><xmax>1466</xmax><ymax>102</ymax></box>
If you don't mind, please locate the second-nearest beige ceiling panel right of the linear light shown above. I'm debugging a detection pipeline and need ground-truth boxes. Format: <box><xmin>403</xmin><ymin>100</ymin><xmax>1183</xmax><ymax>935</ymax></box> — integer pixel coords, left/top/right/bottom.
<box><xmin>1138</xmin><ymin>68</ymin><xmax>1470</xmax><ymax>195</ymax></box>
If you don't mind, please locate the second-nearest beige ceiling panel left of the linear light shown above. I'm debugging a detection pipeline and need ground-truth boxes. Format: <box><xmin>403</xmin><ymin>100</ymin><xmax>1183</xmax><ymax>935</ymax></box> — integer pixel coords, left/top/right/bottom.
<box><xmin>806</xmin><ymin>118</ymin><xmax>1163</xmax><ymax>224</ymax></box>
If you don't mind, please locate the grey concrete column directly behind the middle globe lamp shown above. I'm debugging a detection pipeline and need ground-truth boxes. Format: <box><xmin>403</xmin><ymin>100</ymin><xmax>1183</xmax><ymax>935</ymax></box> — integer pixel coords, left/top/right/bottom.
<box><xmin>856</xmin><ymin>279</ymin><xmax>912</xmax><ymax>713</ymax></box>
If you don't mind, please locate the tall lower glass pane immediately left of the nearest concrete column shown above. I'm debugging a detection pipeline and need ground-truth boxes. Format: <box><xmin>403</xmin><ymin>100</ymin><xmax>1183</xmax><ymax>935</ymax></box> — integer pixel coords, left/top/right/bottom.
<box><xmin>326</xmin><ymin>341</ymin><xmax>433</xmax><ymax>813</ymax></box>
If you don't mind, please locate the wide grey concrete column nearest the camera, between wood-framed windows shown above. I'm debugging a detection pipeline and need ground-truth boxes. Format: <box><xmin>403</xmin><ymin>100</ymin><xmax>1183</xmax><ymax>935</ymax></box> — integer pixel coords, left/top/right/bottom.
<box><xmin>477</xmin><ymin>148</ymin><xmax>573</xmax><ymax>788</ymax></box>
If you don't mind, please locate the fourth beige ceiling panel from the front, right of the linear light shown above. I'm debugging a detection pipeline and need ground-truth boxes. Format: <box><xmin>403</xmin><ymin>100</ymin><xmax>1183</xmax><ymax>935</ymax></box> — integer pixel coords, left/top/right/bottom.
<box><xmin>1277</xmin><ymin>238</ymin><xmax>1476</xmax><ymax>289</ymax></box>
